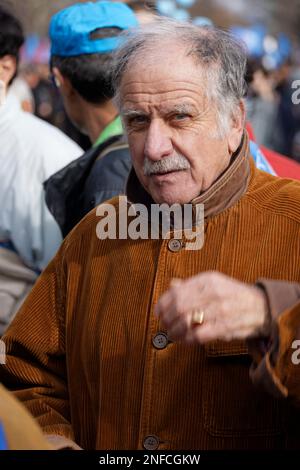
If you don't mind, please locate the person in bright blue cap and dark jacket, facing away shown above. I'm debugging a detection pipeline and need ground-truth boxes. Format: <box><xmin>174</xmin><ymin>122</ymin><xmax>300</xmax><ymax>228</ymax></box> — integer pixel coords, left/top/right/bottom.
<box><xmin>44</xmin><ymin>1</ymin><xmax>137</xmax><ymax>236</ymax></box>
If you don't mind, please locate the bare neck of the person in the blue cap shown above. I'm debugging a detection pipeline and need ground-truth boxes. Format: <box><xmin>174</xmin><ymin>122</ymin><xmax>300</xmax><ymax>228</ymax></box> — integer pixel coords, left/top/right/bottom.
<box><xmin>83</xmin><ymin>101</ymin><xmax>118</xmax><ymax>144</ymax></box>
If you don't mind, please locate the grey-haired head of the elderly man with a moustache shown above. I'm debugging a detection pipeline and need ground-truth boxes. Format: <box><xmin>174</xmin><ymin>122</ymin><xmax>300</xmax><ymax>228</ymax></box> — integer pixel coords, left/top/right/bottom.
<box><xmin>113</xmin><ymin>19</ymin><xmax>246</xmax><ymax>204</ymax></box>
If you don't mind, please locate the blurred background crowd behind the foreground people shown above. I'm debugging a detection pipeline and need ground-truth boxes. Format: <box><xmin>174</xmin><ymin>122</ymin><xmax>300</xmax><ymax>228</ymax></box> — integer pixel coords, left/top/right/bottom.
<box><xmin>0</xmin><ymin>0</ymin><xmax>300</xmax><ymax>162</ymax></box>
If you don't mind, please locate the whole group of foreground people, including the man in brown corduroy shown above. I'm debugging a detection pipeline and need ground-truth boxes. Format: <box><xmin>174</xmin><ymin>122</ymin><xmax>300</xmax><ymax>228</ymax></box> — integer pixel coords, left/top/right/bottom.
<box><xmin>0</xmin><ymin>1</ymin><xmax>300</xmax><ymax>451</ymax></box>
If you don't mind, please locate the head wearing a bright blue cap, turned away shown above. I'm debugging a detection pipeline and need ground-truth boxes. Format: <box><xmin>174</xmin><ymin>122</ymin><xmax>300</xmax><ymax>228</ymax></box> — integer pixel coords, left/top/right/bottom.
<box><xmin>49</xmin><ymin>1</ymin><xmax>137</xmax><ymax>132</ymax></box>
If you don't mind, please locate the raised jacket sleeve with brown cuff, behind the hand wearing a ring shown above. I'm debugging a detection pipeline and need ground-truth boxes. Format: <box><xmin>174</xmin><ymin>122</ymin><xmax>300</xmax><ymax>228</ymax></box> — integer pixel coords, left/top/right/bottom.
<box><xmin>248</xmin><ymin>280</ymin><xmax>300</xmax><ymax>407</ymax></box>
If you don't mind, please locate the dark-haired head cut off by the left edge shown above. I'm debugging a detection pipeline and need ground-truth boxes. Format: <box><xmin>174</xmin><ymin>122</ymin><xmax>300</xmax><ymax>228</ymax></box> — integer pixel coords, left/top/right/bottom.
<box><xmin>0</xmin><ymin>5</ymin><xmax>24</xmax><ymax>91</ymax></box>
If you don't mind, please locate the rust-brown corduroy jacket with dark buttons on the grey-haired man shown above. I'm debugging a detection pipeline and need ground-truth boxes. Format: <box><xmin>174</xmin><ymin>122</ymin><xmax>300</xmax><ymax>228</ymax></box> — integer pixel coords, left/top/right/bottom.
<box><xmin>0</xmin><ymin>134</ymin><xmax>300</xmax><ymax>450</ymax></box>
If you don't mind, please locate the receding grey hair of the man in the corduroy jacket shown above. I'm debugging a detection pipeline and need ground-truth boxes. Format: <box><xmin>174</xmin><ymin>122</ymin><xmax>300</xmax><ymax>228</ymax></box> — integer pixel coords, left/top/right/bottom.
<box><xmin>112</xmin><ymin>18</ymin><xmax>247</xmax><ymax>135</ymax></box>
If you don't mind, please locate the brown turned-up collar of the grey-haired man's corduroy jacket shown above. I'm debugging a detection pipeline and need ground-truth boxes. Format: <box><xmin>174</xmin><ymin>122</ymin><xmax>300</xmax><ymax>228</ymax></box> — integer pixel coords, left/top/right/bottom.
<box><xmin>126</xmin><ymin>131</ymin><xmax>250</xmax><ymax>218</ymax></box>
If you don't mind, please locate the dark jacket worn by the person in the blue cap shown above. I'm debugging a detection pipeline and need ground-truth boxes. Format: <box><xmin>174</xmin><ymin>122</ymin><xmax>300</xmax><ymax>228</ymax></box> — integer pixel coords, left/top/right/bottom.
<box><xmin>44</xmin><ymin>135</ymin><xmax>131</xmax><ymax>237</ymax></box>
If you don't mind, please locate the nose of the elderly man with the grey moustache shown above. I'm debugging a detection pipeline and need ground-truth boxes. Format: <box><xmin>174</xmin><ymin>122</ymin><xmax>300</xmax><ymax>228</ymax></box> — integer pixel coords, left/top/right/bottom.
<box><xmin>144</xmin><ymin>119</ymin><xmax>173</xmax><ymax>160</ymax></box>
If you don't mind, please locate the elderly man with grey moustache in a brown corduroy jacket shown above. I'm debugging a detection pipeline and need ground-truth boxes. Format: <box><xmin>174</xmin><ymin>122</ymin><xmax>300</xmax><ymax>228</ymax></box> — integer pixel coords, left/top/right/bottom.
<box><xmin>1</xmin><ymin>20</ymin><xmax>300</xmax><ymax>450</ymax></box>
